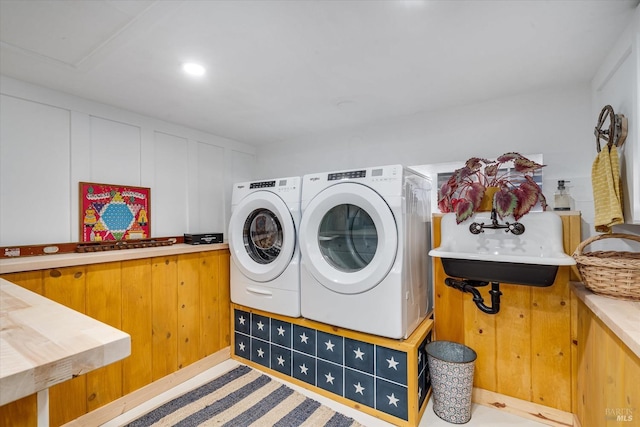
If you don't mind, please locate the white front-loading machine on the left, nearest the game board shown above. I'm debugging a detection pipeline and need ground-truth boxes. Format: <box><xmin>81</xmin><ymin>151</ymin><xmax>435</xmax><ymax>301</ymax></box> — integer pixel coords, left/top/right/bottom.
<box><xmin>229</xmin><ymin>177</ymin><xmax>301</xmax><ymax>317</ymax></box>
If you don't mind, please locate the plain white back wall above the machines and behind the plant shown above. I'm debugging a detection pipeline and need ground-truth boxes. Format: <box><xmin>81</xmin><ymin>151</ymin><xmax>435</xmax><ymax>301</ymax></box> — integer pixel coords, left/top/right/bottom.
<box><xmin>258</xmin><ymin>85</ymin><xmax>596</xmax><ymax>237</ymax></box>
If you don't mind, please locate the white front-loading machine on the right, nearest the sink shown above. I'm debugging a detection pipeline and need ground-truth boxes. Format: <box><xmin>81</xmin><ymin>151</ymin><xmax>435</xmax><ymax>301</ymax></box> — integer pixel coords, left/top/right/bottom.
<box><xmin>299</xmin><ymin>165</ymin><xmax>433</xmax><ymax>339</ymax></box>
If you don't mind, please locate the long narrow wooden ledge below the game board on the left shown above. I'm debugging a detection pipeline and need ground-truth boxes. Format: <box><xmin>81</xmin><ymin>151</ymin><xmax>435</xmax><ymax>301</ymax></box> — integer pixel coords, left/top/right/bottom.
<box><xmin>0</xmin><ymin>243</ymin><xmax>229</xmax><ymax>274</ymax></box>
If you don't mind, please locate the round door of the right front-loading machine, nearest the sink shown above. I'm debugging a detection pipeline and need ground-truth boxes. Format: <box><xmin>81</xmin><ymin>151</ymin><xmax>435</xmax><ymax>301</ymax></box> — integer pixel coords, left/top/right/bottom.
<box><xmin>300</xmin><ymin>183</ymin><xmax>398</xmax><ymax>294</ymax></box>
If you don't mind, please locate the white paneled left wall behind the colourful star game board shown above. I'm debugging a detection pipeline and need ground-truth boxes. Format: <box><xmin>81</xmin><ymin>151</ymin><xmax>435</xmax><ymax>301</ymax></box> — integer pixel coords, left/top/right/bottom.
<box><xmin>0</xmin><ymin>76</ymin><xmax>256</xmax><ymax>246</ymax></box>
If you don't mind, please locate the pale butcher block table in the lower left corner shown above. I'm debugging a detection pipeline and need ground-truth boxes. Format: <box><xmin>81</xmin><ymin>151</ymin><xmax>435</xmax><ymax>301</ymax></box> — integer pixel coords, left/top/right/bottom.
<box><xmin>0</xmin><ymin>279</ymin><xmax>131</xmax><ymax>426</ymax></box>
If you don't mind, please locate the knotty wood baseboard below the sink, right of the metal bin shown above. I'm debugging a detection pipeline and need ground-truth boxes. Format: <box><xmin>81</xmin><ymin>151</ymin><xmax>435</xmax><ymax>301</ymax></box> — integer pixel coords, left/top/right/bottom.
<box><xmin>472</xmin><ymin>388</ymin><xmax>579</xmax><ymax>427</ymax></box>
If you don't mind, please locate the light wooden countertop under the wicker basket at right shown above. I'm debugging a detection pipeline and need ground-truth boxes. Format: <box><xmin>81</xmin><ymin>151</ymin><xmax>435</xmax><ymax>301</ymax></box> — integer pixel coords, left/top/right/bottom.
<box><xmin>571</xmin><ymin>282</ymin><xmax>640</xmax><ymax>358</ymax></box>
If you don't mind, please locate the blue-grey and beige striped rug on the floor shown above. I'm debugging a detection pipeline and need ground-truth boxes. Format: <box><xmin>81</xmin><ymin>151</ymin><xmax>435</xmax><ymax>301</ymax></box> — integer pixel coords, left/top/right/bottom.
<box><xmin>129</xmin><ymin>365</ymin><xmax>361</xmax><ymax>427</ymax></box>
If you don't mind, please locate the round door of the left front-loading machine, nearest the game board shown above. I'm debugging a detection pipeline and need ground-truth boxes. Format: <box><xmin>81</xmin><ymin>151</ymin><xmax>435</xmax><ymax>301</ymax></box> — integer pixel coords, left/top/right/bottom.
<box><xmin>229</xmin><ymin>191</ymin><xmax>296</xmax><ymax>282</ymax></box>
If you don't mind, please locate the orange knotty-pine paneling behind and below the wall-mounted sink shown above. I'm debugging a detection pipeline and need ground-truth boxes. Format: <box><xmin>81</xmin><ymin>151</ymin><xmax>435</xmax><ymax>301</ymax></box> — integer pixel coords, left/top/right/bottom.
<box><xmin>433</xmin><ymin>214</ymin><xmax>580</xmax><ymax>412</ymax></box>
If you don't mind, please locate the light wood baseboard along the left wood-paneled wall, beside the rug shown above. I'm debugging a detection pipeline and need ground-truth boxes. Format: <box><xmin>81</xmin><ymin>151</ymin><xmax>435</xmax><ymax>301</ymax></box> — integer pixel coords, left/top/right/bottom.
<box><xmin>64</xmin><ymin>347</ymin><xmax>231</xmax><ymax>427</ymax></box>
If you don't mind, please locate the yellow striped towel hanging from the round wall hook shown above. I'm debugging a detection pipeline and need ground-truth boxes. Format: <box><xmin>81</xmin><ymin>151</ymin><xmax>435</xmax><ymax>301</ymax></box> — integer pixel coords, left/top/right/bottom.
<box><xmin>591</xmin><ymin>145</ymin><xmax>624</xmax><ymax>233</ymax></box>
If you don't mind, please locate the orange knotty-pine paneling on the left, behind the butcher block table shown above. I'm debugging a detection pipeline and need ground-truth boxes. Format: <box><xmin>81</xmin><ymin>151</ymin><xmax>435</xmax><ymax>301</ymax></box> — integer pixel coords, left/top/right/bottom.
<box><xmin>0</xmin><ymin>250</ymin><xmax>231</xmax><ymax>427</ymax></box>
